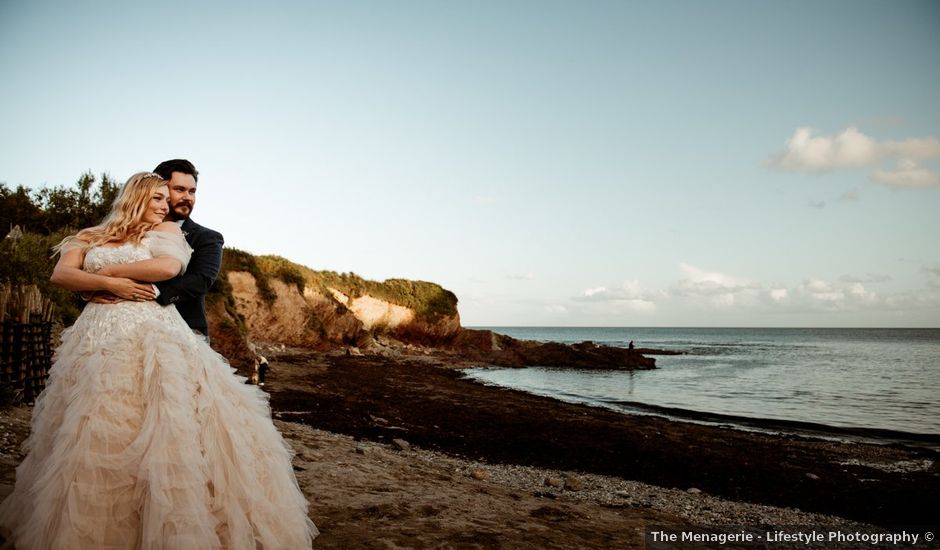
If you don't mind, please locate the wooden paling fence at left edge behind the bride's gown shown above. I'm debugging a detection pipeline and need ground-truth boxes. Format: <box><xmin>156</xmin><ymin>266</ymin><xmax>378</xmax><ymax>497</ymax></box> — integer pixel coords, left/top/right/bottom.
<box><xmin>0</xmin><ymin>284</ymin><xmax>55</xmax><ymax>403</ymax></box>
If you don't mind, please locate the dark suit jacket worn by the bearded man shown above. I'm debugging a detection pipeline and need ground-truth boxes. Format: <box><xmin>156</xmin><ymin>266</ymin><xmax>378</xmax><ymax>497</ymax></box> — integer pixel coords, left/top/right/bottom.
<box><xmin>155</xmin><ymin>219</ymin><xmax>225</xmax><ymax>336</ymax></box>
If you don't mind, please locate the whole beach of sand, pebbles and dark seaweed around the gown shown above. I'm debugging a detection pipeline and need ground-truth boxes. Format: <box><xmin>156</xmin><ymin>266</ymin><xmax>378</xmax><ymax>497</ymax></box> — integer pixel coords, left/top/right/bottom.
<box><xmin>0</xmin><ymin>349</ymin><xmax>940</xmax><ymax>548</ymax></box>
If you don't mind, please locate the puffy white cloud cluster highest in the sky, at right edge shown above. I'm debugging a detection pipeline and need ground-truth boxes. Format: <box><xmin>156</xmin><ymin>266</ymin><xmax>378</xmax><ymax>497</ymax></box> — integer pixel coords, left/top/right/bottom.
<box><xmin>767</xmin><ymin>127</ymin><xmax>940</xmax><ymax>190</ymax></box>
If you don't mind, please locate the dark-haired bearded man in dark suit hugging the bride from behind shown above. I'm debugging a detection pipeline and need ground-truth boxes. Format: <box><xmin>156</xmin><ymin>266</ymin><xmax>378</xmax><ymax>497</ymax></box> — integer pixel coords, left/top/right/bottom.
<box><xmin>153</xmin><ymin>159</ymin><xmax>225</xmax><ymax>341</ymax></box>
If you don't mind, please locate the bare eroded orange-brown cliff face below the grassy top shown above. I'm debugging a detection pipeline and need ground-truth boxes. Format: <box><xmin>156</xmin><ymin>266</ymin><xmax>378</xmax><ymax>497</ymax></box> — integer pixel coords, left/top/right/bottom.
<box><xmin>211</xmin><ymin>271</ymin><xmax>460</xmax><ymax>349</ymax></box>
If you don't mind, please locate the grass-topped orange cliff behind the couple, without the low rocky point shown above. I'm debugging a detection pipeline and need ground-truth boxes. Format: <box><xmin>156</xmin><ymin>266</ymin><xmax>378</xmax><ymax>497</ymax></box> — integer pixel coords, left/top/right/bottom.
<box><xmin>207</xmin><ymin>249</ymin><xmax>461</xmax><ymax>368</ymax></box>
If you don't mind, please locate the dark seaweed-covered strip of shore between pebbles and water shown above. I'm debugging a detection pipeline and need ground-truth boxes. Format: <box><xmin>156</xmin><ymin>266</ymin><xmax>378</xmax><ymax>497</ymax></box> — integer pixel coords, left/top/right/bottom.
<box><xmin>268</xmin><ymin>352</ymin><xmax>940</xmax><ymax>525</ymax></box>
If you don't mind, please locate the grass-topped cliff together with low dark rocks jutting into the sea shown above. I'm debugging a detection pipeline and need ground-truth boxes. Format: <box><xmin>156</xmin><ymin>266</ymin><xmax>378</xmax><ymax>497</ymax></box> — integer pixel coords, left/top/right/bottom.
<box><xmin>207</xmin><ymin>249</ymin><xmax>656</xmax><ymax>376</ymax></box>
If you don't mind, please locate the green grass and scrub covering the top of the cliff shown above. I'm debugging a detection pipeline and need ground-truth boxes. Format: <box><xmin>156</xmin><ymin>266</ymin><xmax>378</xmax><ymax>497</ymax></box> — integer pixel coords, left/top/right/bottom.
<box><xmin>220</xmin><ymin>248</ymin><xmax>457</xmax><ymax>322</ymax></box>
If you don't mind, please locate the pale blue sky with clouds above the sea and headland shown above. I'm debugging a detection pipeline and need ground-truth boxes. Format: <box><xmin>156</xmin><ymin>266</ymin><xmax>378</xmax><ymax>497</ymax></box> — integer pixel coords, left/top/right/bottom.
<box><xmin>0</xmin><ymin>0</ymin><xmax>940</xmax><ymax>326</ymax></box>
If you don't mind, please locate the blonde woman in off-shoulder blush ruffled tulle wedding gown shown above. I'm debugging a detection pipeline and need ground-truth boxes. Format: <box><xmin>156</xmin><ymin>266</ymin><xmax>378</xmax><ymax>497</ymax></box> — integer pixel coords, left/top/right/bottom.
<box><xmin>0</xmin><ymin>172</ymin><xmax>317</xmax><ymax>550</ymax></box>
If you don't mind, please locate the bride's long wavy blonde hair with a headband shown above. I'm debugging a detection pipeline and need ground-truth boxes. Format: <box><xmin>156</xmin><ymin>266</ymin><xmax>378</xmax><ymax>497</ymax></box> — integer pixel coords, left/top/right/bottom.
<box><xmin>52</xmin><ymin>172</ymin><xmax>167</xmax><ymax>254</ymax></box>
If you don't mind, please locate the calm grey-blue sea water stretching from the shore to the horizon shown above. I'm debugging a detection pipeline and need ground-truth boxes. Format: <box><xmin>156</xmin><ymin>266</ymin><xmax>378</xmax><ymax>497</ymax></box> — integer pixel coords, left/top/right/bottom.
<box><xmin>468</xmin><ymin>327</ymin><xmax>940</xmax><ymax>435</ymax></box>
